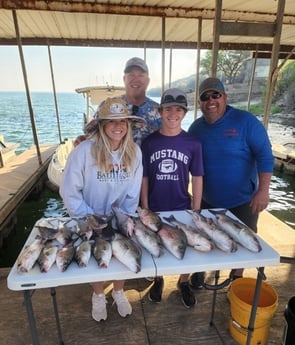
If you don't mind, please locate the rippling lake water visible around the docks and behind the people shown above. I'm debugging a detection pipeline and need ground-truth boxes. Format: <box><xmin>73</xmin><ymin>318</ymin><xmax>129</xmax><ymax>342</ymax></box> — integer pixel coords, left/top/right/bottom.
<box><xmin>0</xmin><ymin>92</ymin><xmax>295</xmax><ymax>267</ymax></box>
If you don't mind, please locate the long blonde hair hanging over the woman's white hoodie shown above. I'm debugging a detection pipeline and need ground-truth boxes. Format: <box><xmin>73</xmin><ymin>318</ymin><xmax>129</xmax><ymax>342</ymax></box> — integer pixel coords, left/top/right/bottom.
<box><xmin>92</xmin><ymin>120</ymin><xmax>137</xmax><ymax>172</ymax></box>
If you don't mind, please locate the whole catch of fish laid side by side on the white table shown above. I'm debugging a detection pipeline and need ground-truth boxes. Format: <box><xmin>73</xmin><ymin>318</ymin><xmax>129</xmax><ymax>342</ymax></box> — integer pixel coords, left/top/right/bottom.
<box><xmin>17</xmin><ymin>205</ymin><xmax>261</xmax><ymax>273</ymax></box>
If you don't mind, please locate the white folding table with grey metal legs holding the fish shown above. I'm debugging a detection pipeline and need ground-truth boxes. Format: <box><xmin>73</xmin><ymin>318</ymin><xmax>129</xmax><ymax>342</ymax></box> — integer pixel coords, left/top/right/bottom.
<box><xmin>7</xmin><ymin>210</ymin><xmax>280</xmax><ymax>345</ymax></box>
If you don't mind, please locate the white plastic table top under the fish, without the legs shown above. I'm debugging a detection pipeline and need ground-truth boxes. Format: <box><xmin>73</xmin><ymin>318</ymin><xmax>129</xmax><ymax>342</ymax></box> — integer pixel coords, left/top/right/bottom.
<box><xmin>7</xmin><ymin>210</ymin><xmax>280</xmax><ymax>290</ymax></box>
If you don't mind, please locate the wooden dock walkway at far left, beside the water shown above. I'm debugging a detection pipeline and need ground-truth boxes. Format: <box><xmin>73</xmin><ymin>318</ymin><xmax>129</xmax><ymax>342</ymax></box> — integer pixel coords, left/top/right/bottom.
<box><xmin>0</xmin><ymin>145</ymin><xmax>57</xmax><ymax>244</ymax></box>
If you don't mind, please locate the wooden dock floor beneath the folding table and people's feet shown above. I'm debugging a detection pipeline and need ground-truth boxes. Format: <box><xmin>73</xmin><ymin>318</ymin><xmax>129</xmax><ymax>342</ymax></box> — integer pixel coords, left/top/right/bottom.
<box><xmin>0</xmin><ymin>211</ymin><xmax>295</xmax><ymax>345</ymax></box>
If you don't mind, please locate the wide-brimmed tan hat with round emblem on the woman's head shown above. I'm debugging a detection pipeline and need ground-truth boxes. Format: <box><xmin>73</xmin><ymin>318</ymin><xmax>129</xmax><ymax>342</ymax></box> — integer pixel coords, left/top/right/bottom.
<box><xmin>97</xmin><ymin>97</ymin><xmax>146</xmax><ymax>126</ymax></box>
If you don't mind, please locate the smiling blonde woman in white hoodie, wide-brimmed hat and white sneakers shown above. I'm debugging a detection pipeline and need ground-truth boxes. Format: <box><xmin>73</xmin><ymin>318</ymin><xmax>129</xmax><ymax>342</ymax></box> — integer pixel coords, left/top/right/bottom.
<box><xmin>60</xmin><ymin>98</ymin><xmax>145</xmax><ymax>322</ymax></box>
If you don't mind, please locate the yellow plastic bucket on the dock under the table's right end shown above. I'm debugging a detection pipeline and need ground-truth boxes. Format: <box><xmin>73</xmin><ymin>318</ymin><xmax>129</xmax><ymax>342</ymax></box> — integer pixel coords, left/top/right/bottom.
<box><xmin>228</xmin><ymin>278</ymin><xmax>278</xmax><ymax>345</ymax></box>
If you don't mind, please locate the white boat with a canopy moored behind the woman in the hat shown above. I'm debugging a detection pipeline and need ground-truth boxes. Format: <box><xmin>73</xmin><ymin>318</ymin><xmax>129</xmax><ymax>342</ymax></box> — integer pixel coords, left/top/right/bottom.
<box><xmin>47</xmin><ymin>84</ymin><xmax>125</xmax><ymax>191</ymax></box>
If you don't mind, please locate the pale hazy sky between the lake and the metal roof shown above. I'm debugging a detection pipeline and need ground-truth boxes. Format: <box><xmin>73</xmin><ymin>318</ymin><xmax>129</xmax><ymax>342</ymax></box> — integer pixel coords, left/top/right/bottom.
<box><xmin>0</xmin><ymin>46</ymin><xmax>200</xmax><ymax>92</ymax></box>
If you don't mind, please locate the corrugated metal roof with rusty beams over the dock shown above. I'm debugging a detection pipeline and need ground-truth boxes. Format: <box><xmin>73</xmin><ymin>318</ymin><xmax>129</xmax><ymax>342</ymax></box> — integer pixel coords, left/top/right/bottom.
<box><xmin>0</xmin><ymin>0</ymin><xmax>295</xmax><ymax>52</ymax></box>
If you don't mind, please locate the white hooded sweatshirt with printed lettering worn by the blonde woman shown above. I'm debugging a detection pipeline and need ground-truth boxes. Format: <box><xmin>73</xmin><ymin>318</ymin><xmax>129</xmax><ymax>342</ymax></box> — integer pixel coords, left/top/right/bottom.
<box><xmin>59</xmin><ymin>139</ymin><xmax>142</xmax><ymax>217</ymax></box>
